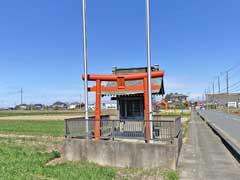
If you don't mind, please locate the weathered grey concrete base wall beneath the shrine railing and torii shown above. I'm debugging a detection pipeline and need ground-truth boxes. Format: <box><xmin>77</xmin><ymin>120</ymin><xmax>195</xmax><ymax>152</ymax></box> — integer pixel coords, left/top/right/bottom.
<box><xmin>64</xmin><ymin>136</ymin><xmax>182</xmax><ymax>169</ymax></box>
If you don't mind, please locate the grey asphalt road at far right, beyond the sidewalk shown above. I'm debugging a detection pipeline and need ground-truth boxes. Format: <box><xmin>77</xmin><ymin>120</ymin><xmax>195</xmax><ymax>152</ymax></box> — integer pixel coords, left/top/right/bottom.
<box><xmin>199</xmin><ymin>110</ymin><xmax>240</xmax><ymax>150</ymax></box>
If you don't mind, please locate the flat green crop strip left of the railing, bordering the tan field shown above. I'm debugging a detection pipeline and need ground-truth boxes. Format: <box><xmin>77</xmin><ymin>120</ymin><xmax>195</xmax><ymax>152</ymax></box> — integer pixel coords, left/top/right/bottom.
<box><xmin>0</xmin><ymin>120</ymin><xmax>64</xmax><ymax>136</ymax></box>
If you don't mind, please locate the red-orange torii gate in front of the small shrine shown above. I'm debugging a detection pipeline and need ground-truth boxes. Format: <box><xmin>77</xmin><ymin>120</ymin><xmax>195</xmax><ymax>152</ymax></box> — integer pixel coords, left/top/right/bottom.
<box><xmin>82</xmin><ymin>70</ymin><xmax>164</xmax><ymax>142</ymax></box>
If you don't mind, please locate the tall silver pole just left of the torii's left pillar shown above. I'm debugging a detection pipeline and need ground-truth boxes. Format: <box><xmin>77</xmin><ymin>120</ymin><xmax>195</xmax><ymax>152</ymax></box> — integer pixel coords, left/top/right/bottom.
<box><xmin>82</xmin><ymin>0</ymin><xmax>88</xmax><ymax>138</ymax></box>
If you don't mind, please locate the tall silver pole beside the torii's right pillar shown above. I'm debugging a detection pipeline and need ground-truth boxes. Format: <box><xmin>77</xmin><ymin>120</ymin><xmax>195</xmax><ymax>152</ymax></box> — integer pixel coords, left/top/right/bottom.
<box><xmin>146</xmin><ymin>0</ymin><xmax>153</xmax><ymax>139</ymax></box>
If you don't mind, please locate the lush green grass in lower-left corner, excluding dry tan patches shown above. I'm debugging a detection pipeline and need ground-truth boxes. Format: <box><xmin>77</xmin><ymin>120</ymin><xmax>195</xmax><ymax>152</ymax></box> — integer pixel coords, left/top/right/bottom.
<box><xmin>0</xmin><ymin>140</ymin><xmax>116</xmax><ymax>180</ymax></box>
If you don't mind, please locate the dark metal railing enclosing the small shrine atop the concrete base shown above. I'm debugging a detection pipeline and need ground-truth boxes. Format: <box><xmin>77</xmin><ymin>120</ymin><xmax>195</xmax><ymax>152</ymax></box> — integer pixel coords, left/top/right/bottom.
<box><xmin>65</xmin><ymin>117</ymin><xmax>181</xmax><ymax>141</ymax></box>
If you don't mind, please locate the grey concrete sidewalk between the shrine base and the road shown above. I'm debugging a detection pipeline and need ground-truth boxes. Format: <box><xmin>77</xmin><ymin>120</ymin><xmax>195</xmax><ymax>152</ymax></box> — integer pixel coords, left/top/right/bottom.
<box><xmin>179</xmin><ymin>112</ymin><xmax>240</xmax><ymax>180</ymax></box>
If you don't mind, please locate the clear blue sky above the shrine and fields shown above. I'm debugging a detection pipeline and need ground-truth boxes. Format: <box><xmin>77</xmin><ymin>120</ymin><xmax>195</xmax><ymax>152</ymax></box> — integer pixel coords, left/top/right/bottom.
<box><xmin>0</xmin><ymin>0</ymin><xmax>240</xmax><ymax>106</ymax></box>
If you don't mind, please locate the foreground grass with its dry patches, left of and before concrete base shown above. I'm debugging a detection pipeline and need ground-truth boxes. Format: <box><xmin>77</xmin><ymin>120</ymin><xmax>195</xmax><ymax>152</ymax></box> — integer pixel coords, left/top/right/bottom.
<box><xmin>0</xmin><ymin>137</ymin><xmax>179</xmax><ymax>180</ymax></box>
